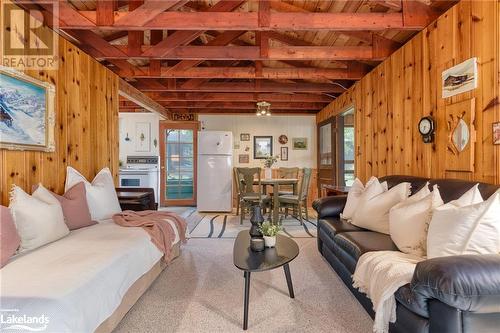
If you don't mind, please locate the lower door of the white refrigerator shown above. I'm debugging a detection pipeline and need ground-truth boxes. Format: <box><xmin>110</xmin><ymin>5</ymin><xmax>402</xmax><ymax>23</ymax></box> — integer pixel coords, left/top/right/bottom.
<box><xmin>197</xmin><ymin>155</ymin><xmax>233</xmax><ymax>212</ymax></box>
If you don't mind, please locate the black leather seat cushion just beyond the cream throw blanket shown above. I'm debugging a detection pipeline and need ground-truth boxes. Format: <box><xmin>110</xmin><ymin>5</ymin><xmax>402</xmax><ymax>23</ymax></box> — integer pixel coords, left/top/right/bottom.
<box><xmin>333</xmin><ymin>231</ymin><xmax>398</xmax><ymax>261</ymax></box>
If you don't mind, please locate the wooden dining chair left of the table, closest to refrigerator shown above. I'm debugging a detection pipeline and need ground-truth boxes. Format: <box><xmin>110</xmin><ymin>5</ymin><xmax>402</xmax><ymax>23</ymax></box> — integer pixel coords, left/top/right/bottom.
<box><xmin>236</xmin><ymin>168</ymin><xmax>272</xmax><ymax>224</ymax></box>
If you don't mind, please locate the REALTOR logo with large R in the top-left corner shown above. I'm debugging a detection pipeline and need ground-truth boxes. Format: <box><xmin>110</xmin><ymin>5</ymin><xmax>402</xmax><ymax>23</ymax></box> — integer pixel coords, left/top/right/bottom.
<box><xmin>0</xmin><ymin>0</ymin><xmax>59</xmax><ymax>69</ymax></box>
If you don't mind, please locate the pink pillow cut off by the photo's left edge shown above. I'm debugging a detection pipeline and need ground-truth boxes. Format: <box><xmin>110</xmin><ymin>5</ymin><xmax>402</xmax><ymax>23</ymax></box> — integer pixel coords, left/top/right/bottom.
<box><xmin>0</xmin><ymin>206</ymin><xmax>21</xmax><ymax>268</ymax></box>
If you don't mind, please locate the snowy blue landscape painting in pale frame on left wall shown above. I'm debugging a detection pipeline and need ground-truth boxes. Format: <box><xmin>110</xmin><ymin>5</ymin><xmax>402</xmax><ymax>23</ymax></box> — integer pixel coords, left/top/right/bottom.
<box><xmin>0</xmin><ymin>66</ymin><xmax>55</xmax><ymax>152</ymax></box>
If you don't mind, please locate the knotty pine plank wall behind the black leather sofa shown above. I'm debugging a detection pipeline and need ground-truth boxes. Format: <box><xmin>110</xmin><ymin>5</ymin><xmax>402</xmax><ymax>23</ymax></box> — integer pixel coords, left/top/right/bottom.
<box><xmin>317</xmin><ymin>0</ymin><xmax>500</xmax><ymax>184</ymax></box>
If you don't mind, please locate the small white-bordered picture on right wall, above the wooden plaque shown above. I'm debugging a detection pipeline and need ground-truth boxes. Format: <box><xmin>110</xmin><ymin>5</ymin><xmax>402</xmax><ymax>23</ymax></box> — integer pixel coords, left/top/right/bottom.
<box><xmin>441</xmin><ymin>58</ymin><xmax>478</xmax><ymax>98</ymax></box>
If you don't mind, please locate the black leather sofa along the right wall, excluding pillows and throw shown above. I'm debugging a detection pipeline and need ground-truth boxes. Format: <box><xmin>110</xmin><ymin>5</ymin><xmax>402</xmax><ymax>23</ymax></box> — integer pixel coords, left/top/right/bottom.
<box><xmin>313</xmin><ymin>176</ymin><xmax>500</xmax><ymax>333</ymax></box>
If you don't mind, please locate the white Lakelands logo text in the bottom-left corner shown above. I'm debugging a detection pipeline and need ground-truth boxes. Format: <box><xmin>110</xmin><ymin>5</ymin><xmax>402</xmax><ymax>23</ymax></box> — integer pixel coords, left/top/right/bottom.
<box><xmin>0</xmin><ymin>309</ymin><xmax>50</xmax><ymax>332</ymax></box>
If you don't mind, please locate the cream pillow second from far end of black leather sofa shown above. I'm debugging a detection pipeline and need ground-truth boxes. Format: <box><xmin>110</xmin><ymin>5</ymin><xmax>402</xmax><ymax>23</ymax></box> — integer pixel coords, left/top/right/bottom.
<box><xmin>352</xmin><ymin>181</ymin><xmax>411</xmax><ymax>234</ymax></box>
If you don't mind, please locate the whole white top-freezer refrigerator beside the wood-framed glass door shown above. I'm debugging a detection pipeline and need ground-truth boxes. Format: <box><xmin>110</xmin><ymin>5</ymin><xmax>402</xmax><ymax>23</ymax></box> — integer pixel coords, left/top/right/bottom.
<box><xmin>197</xmin><ymin>131</ymin><xmax>233</xmax><ymax>212</ymax></box>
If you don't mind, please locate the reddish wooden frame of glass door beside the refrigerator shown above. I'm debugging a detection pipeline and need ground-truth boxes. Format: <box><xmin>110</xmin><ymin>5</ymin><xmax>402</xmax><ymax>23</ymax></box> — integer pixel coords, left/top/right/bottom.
<box><xmin>158</xmin><ymin>120</ymin><xmax>200</xmax><ymax>207</ymax></box>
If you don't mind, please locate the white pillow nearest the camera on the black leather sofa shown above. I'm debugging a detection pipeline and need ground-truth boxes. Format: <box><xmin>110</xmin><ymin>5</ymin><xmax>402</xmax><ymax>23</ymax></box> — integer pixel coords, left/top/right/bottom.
<box><xmin>427</xmin><ymin>190</ymin><xmax>500</xmax><ymax>258</ymax></box>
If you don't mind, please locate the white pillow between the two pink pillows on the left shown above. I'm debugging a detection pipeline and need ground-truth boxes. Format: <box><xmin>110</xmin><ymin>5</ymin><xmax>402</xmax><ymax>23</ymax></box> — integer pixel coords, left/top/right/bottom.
<box><xmin>9</xmin><ymin>185</ymin><xmax>69</xmax><ymax>252</ymax></box>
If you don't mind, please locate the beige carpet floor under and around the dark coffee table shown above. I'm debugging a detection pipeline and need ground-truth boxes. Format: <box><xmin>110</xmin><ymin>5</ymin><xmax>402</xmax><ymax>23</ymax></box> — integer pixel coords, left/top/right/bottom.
<box><xmin>115</xmin><ymin>238</ymin><xmax>373</xmax><ymax>333</ymax></box>
